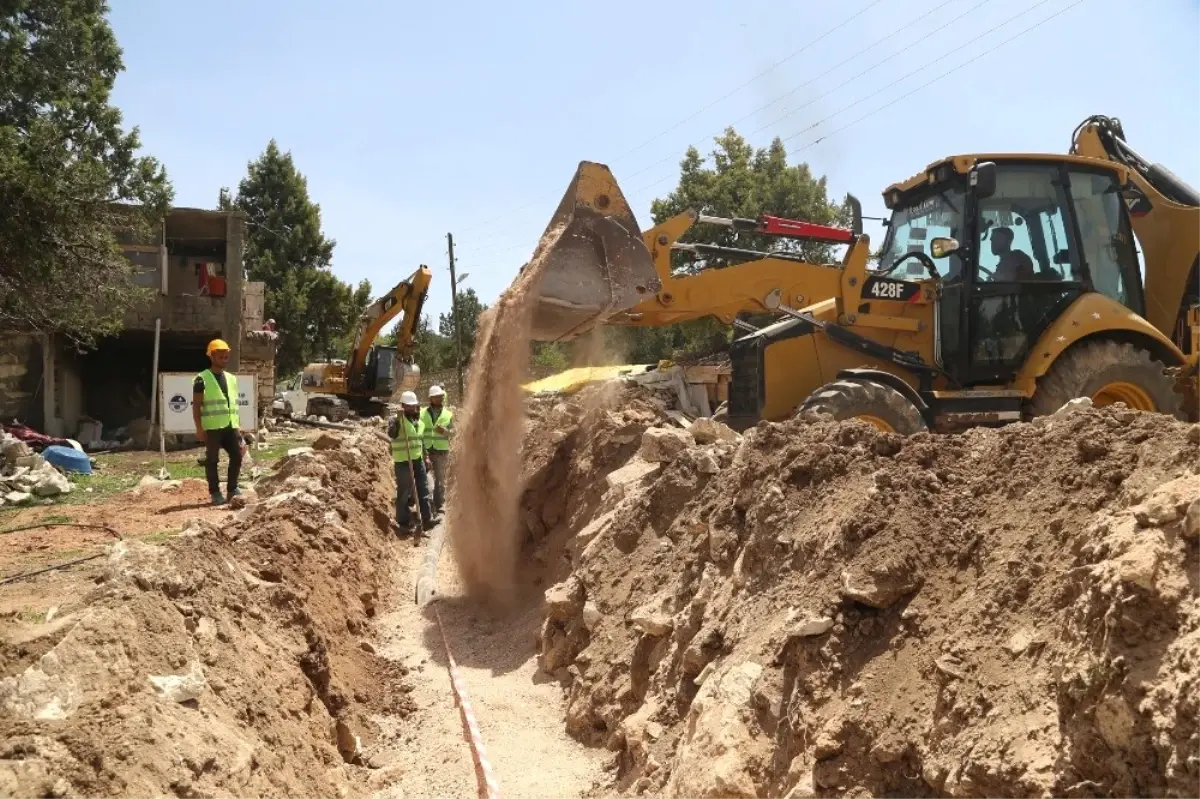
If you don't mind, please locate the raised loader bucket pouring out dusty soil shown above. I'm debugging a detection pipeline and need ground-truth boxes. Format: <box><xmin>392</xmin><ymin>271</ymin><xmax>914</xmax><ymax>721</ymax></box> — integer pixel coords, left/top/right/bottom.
<box><xmin>530</xmin><ymin>161</ymin><xmax>661</xmax><ymax>341</ymax></box>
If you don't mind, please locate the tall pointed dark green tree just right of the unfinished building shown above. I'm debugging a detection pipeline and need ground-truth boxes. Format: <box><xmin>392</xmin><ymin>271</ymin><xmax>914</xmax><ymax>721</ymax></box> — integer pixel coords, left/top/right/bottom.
<box><xmin>217</xmin><ymin>139</ymin><xmax>371</xmax><ymax>374</ymax></box>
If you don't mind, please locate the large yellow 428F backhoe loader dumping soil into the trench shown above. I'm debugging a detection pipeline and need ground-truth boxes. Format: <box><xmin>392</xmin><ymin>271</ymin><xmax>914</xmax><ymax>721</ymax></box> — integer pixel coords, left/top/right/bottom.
<box><xmin>520</xmin><ymin>116</ymin><xmax>1200</xmax><ymax>434</ymax></box>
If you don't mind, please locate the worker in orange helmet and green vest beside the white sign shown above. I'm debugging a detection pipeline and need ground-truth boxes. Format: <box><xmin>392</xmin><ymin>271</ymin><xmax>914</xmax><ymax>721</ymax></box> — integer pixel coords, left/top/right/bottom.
<box><xmin>192</xmin><ymin>338</ymin><xmax>241</xmax><ymax>505</ymax></box>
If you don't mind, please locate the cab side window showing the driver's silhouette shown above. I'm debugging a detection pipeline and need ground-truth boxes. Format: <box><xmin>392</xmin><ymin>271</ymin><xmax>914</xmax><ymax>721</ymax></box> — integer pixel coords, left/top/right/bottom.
<box><xmin>976</xmin><ymin>166</ymin><xmax>1081</xmax><ymax>283</ymax></box>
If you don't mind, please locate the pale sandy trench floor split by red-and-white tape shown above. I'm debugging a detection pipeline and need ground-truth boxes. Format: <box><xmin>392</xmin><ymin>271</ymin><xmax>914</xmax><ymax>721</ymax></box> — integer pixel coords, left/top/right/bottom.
<box><xmin>371</xmin><ymin>523</ymin><xmax>605</xmax><ymax>799</ymax></box>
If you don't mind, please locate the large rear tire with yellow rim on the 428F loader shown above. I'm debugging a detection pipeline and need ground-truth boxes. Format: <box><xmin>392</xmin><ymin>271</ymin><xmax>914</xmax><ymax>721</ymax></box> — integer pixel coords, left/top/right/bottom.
<box><xmin>1030</xmin><ymin>341</ymin><xmax>1184</xmax><ymax>419</ymax></box>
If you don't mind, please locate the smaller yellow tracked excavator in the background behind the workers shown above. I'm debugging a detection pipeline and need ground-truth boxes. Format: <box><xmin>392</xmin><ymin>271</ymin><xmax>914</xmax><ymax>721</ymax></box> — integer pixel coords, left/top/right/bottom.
<box><xmin>300</xmin><ymin>265</ymin><xmax>433</xmax><ymax>419</ymax></box>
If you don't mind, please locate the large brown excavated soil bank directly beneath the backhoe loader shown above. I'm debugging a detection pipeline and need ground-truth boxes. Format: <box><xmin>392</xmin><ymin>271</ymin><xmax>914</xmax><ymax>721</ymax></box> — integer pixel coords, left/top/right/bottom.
<box><xmin>524</xmin><ymin>386</ymin><xmax>1200</xmax><ymax>799</ymax></box>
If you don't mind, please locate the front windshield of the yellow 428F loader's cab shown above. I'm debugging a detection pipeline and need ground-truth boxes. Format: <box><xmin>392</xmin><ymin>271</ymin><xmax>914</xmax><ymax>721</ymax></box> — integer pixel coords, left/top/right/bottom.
<box><xmin>880</xmin><ymin>186</ymin><xmax>966</xmax><ymax>278</ymax></box>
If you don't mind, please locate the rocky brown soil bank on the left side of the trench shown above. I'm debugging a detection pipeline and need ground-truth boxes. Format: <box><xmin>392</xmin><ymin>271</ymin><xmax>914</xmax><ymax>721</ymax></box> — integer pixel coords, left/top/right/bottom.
<box><xmin>0</xmin><ymin>431</ymin><xmax>408</xmax><ymax>799</ymax></box>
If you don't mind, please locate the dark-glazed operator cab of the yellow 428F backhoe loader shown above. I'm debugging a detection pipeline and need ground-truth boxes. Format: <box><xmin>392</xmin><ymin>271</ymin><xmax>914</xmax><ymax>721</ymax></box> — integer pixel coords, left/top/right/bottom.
<box><xmin>881</xmin><ymin>158</ymin><xmax>1145</xmax><ymax>388</ymax></box>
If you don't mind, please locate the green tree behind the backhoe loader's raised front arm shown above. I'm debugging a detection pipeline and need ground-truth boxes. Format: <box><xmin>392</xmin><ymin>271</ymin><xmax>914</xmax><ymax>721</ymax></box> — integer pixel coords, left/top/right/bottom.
<box><xmin>608</xmin><ymin>127</ymin><xmax>850</xmax><ymax>362</ymax></box>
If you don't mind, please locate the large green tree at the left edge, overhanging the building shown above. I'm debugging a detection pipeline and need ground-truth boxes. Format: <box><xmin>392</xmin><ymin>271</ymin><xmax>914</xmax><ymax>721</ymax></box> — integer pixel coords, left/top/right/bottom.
<box><xmin>0</xmin><ymin>0</ymin><xmax>173</xmax><ymax>344</ymax></box>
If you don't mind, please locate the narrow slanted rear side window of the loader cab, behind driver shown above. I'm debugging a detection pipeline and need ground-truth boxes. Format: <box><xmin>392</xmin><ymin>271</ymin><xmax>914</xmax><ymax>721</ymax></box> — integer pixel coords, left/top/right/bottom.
<box><xmin>1069</xmin><ymin>170</ymin><xmax>1141</xmax><ymax>313</ymax></box>
